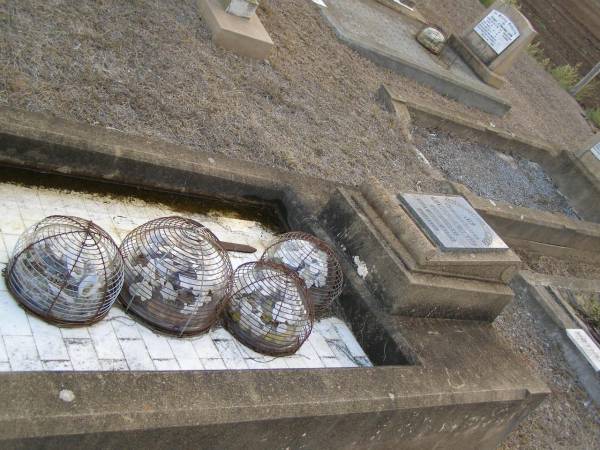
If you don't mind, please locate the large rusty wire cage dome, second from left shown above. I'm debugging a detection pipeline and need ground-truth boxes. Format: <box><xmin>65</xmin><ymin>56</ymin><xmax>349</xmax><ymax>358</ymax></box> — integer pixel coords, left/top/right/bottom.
<box><xmin>120</xmin><ymin>217</ymin><xmax>233</xmax><ymax>336</ymax></box>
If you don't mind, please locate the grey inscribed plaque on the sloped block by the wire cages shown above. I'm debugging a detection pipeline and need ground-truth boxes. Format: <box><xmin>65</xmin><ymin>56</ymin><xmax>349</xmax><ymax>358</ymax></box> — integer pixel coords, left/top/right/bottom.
<box><xmin>398</xmin><ymin>194</ymin><xmax>509</xmax><ymax>252</ymax></box>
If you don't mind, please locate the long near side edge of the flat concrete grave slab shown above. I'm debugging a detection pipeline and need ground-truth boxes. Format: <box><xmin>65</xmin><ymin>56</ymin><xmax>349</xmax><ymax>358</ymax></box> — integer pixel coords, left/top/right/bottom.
<box><xmin>321</xmin><ymin>11</ymin><xmax>511</xmax><ymax>116</ymax></box>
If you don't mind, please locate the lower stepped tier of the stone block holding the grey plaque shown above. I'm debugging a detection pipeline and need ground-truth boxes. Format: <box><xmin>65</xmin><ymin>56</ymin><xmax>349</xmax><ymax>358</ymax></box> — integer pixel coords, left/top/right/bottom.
<box><xmin>321</xmin><ymin>189</ymin><xmax>513</xmax><ymax>321</ymax></box>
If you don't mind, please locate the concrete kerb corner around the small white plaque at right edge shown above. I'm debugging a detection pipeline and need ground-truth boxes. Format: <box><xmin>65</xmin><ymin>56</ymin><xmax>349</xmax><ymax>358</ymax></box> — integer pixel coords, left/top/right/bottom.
<box><xmin>511</xmin><ymin>271</ymin><xmax>600</xmax><ymax>405</ymax></box>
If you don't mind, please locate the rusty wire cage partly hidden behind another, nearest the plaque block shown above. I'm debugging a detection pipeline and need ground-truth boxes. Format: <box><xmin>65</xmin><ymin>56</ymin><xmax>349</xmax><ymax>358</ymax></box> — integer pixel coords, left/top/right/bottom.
<box><xmin>261</xmin><ymin>232</ymin><xmax>344</xmax><ymax>314</ymax></box>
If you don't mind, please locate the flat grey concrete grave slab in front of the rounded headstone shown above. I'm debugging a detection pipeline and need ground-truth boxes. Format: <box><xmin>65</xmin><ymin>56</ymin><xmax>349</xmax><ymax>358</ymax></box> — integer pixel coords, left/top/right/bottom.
<box><xmin>322</xmin><ymin>0</ymin><xmax>510</xmax><ymax>116</ymax></box>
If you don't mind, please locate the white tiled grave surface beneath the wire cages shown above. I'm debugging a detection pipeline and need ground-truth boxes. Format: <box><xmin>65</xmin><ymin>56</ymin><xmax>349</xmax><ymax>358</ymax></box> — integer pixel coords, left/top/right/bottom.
<box><xmin>0</xmin><ymin>183</ymin><xmax>371</xmax><ymax>371</ymax></box>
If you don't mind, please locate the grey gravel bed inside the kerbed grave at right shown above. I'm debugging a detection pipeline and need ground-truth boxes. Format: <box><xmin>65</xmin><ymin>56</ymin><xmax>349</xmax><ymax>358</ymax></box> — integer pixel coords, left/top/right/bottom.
<box><xmin>415</xmin><ymin>129</ymin><xmax>577</xmax><ymax>217</ymax></box>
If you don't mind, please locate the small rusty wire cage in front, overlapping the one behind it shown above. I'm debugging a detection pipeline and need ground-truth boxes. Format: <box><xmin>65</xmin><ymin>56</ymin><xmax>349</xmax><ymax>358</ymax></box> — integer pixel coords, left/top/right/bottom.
<box><xmin>224</xmin><ymin>261</ymin><xmax>314</xmax><ymax>356</ymax></box>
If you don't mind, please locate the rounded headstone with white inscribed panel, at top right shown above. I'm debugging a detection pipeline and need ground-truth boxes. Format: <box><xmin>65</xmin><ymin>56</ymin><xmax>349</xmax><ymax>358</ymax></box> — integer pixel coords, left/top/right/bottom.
<box><xmin>449</xmin><ymin>0</ymin><xmax>537</xmax><ymax>88</ymax></box>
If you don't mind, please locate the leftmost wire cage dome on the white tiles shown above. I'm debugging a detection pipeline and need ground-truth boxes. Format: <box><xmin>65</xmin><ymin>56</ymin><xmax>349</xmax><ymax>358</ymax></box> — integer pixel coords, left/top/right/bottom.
<box><xmin>6</xmin><ymin>216</ymin><xmax>123</xmax><ymax>326</ymax></box>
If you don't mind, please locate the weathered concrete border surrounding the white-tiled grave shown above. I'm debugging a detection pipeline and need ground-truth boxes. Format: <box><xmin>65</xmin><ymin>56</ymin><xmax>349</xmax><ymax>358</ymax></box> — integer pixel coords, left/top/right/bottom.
<box><xmin>0</xmin><ymin>108</ymin><xmax>548</xmax><ymax>450</ymax></box>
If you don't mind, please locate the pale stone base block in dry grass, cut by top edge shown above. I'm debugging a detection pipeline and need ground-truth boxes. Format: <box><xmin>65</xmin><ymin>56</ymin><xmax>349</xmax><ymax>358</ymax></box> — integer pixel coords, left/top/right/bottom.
<box><xmin>198</xmin><ymin>0</ymin><xmax>273</xmax><ymax>59</ymax></box>
